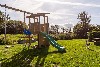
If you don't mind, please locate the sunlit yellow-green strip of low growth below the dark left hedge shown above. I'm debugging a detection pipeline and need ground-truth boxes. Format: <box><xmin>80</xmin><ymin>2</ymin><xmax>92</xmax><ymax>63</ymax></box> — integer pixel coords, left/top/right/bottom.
<box><xmin>0</xmin><ymin>34</ymin><xmax>37</xmax><ymax>45</ymax></box>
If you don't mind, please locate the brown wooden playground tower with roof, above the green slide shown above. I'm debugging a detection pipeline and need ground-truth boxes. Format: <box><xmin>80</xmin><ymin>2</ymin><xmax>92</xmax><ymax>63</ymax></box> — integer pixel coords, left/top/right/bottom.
<box><xmin>26</xmin><ymin>13</ymin><xmax>50</xmax><ymax>47</ymax></box>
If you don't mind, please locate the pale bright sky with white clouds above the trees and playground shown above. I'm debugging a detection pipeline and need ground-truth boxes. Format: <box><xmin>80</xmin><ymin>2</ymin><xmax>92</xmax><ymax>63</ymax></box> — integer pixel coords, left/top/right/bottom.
<box><xmin>0</xmin><ymin>0</ymin><xmax>100</xmax><ymax>25</ymax></box>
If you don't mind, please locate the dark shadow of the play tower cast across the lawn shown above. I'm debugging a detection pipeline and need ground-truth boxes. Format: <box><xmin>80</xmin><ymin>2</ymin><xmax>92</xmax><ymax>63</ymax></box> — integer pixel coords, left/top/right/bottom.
<box><xmin>2</xmin><ymin>48</ymin><xmax>62</xmax><ymax>67</ymax></box>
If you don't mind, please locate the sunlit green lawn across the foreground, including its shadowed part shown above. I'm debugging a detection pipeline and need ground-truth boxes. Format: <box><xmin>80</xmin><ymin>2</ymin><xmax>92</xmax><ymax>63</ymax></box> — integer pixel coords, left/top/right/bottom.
<box><xmin>0</xmin><ymin>39</ymin><xmax>100</xmax><ymax>67</ymax></box>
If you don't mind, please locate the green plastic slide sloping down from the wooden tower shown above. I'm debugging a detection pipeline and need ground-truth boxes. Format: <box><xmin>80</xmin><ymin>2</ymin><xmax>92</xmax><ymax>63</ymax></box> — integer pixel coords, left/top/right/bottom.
<box><xmin>40</xmin><ymin>32</ymin><xmax>65</xmax><ymax>52</ymax></box>
